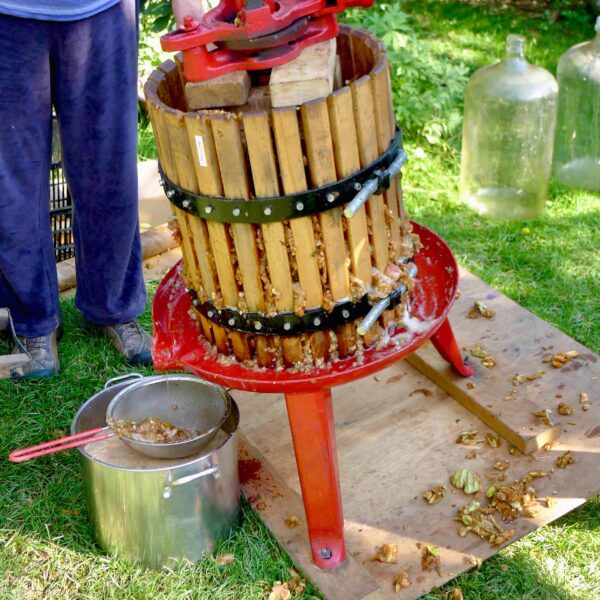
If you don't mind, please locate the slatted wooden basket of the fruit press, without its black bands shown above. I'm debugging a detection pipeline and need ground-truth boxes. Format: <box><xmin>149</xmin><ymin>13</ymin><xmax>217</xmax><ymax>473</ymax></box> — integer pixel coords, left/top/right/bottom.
<box><xmin>144</xmin><ymin>26</ymin><xmax>418</xmax><ymax>368</ymax></box>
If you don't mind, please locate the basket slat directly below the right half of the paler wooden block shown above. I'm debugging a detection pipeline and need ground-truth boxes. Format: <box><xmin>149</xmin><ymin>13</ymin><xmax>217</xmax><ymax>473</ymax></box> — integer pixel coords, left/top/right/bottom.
<box><xmin>300</xmin><ymin>100</ymin><xmax>356</xmax><ymax>356</ymax></box>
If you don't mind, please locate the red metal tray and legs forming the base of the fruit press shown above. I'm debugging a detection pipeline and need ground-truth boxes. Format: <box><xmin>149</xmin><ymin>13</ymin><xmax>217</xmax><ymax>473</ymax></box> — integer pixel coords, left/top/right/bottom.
<box><xmin>153</xmin><ymin>223</ymin><xmax>474</xmax><ymax>569</ymax></box>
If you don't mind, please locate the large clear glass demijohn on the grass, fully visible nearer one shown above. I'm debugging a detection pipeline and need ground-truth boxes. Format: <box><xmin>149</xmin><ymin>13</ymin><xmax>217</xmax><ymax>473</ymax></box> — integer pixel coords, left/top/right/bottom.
<box><xmin>460</xmin><ymin>35</ymin><xmax>558</xmax><ymax>219</ymax></box>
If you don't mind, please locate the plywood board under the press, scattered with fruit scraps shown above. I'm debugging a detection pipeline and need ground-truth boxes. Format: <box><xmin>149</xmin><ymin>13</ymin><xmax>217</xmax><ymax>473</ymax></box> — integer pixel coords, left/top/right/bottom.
<box><xmin>233</xmin><ymin>273</ymin><xmax>600</xmax><ymax>600</ymax></box>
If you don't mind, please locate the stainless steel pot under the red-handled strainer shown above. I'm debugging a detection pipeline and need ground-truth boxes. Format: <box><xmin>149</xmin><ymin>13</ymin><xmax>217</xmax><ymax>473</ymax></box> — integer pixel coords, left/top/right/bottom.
<box><xmin>71</xmin><ymin>374</ymin><xmax>240</xmax><ymax>569</ymax></box>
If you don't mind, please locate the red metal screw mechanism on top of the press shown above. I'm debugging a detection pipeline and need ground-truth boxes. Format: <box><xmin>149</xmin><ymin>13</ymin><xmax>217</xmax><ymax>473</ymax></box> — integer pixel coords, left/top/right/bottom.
<box><xmin>161</xmin><ymin>0</ymin><xmax>374</xmax><ymax>81</ymax></box>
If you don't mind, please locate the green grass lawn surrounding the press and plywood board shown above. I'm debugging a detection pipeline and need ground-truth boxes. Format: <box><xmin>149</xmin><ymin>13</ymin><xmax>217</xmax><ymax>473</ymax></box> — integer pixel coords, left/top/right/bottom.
<box><xmin>0</xmin><ymin>0</ymin><xmax>600</xmax><ymax>600</ymax></box>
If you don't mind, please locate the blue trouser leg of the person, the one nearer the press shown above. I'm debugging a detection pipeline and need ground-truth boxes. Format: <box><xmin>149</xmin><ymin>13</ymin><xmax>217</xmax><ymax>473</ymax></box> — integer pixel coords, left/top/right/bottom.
<box><xmin>52</xmin><ymin>0</ymin><xmax>146</xmax><ymax>325</ymax></box>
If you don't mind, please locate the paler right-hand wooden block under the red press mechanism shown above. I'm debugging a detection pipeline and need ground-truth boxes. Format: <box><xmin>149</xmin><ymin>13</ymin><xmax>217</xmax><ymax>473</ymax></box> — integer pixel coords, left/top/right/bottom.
<box><xmin>269</xmin><ymin>38</ymin><xmax>336</xmax><ymax>108</ymax></box>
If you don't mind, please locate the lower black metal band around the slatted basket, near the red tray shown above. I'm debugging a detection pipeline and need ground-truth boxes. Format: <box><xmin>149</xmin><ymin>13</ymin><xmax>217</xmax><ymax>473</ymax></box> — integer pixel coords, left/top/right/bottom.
<box><xmin>187</xmin><ymin>284</ymin><xmax>406</xmax><ymax>336</ymax></box>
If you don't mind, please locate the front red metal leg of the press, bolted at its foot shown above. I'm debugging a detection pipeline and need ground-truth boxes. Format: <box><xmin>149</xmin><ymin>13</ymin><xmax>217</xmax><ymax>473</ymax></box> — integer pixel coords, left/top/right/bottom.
<box><xmin>285</xmin><ymin>389</ymin><xmax>346</xmax><ymax>569</ymax></box>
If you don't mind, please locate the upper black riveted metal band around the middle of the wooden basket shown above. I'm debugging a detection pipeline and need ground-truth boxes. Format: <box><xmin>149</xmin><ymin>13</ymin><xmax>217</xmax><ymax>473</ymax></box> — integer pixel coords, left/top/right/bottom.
<box><xmin>158</xmin><ymin>130</ymin><xmax>404</xmax><ymax>223</ymax></box>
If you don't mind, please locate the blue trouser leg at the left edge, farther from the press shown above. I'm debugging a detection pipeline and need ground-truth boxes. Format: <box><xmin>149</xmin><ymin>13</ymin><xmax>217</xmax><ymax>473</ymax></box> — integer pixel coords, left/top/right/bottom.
<box><xmin>0</xmin><ymin>15</ymin><xmax>59</xmax><ymax>337</ymax></box>
